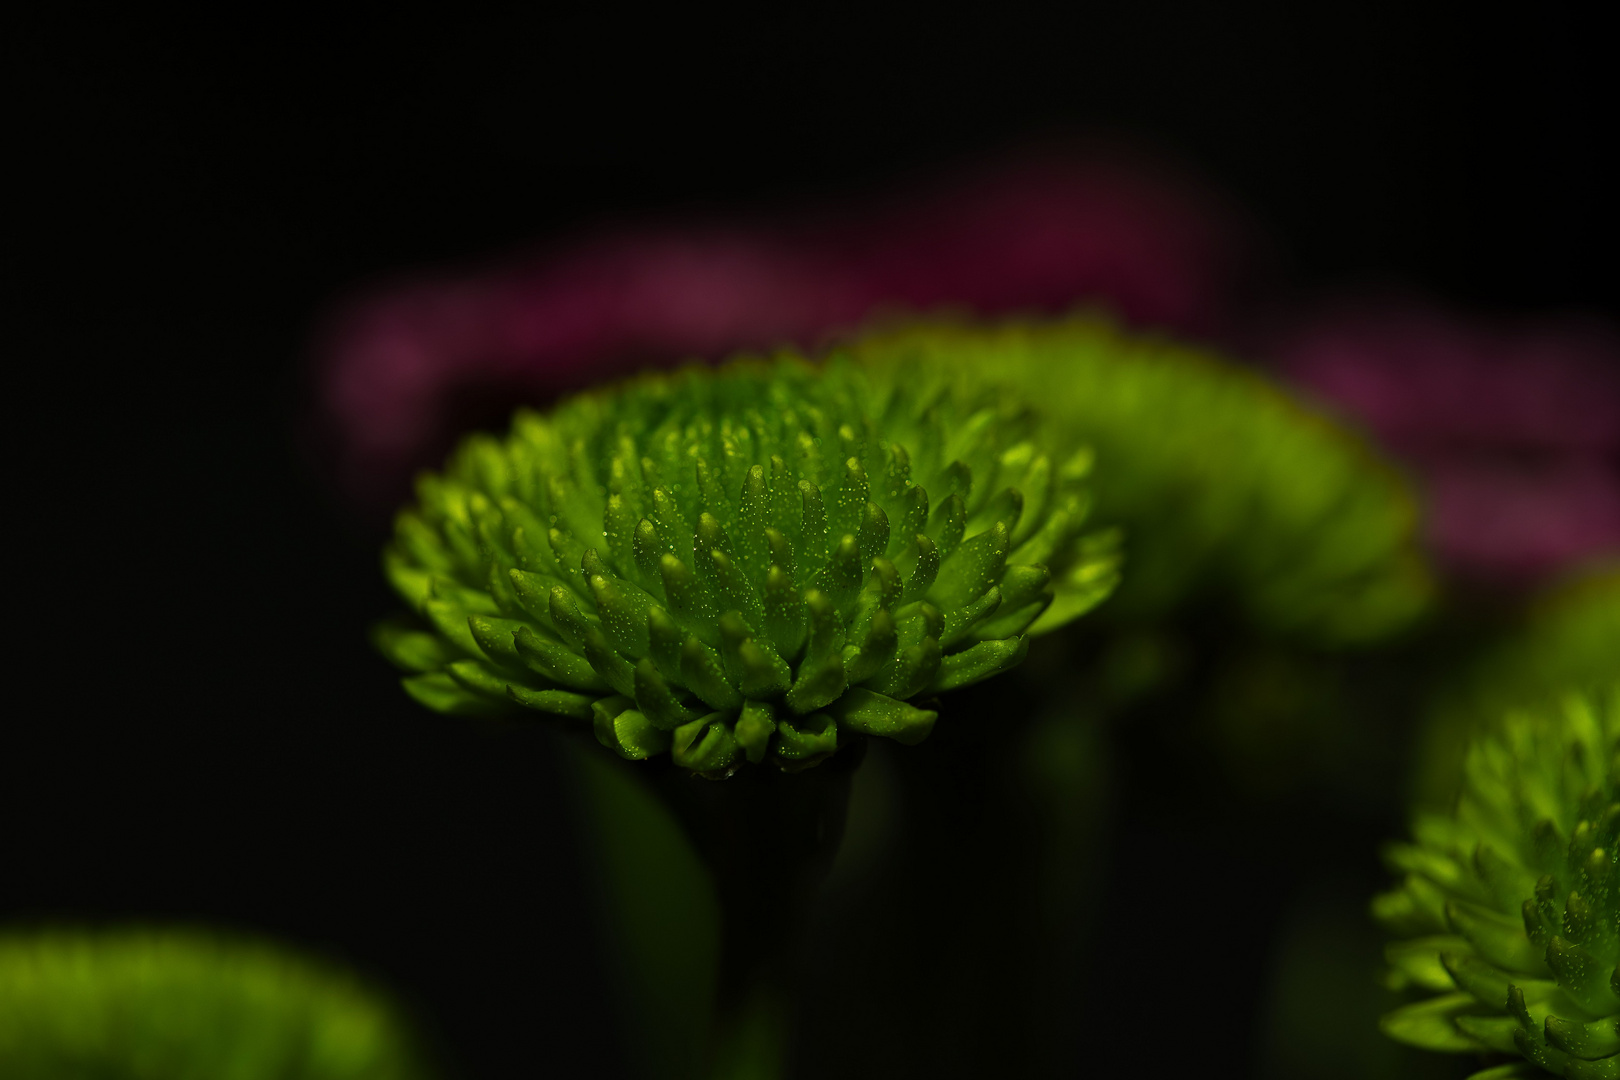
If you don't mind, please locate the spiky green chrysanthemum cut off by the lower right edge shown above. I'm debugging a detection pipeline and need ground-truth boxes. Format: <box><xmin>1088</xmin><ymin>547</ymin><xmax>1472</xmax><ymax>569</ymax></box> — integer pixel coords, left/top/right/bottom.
<box><xmin>1374</xmin><ymin>685</ymin><xmax>1620</xmax><ymax>1080</ymax></box>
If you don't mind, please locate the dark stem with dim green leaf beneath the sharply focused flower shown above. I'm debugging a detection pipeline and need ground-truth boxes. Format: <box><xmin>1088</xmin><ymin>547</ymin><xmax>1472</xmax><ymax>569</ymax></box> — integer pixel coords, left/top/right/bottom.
<box><xmin>570</xmin><ymin>740</ymin><xmax>865</xmax><ymax>1080</ymax></box>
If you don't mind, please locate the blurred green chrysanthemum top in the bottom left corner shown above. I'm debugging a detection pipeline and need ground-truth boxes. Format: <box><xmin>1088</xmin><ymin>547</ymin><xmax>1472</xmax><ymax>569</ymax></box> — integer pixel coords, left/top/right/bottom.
<box><xmin>0</xmin><ymin>931</ymin><xmax>426</xmax><ymax>1080</ymax></box>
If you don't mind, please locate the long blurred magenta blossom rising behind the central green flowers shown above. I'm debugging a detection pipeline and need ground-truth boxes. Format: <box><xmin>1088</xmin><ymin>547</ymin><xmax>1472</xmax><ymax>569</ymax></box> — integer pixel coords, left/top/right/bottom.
<box><xmin>318</xmin><ymin>157</ymin><xmax>1239</xmax><ymax>505</ymax></box>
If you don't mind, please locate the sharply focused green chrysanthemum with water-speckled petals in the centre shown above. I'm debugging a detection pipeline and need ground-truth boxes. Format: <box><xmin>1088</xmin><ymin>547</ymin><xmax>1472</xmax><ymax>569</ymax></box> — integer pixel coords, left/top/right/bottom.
<box><xmin>377</xmin><ymin>359</ymin><xmax>1115</xmax><ymax>776</ymax></box>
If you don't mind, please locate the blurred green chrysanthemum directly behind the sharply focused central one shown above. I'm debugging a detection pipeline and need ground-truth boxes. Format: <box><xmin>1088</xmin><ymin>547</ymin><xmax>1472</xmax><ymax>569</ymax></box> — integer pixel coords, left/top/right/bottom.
<box><xmin>849</xmin><ymin>317</ymin><xmax>1430</xmax><ymax>644</ymax></box>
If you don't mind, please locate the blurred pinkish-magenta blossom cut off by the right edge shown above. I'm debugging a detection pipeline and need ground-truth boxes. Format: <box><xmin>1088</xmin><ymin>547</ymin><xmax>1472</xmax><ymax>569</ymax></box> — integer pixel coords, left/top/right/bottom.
<box><xmin>1275</xmin><ymin>306</ymin><xmax>1620</xmax><ymax>583</ymax></box>
